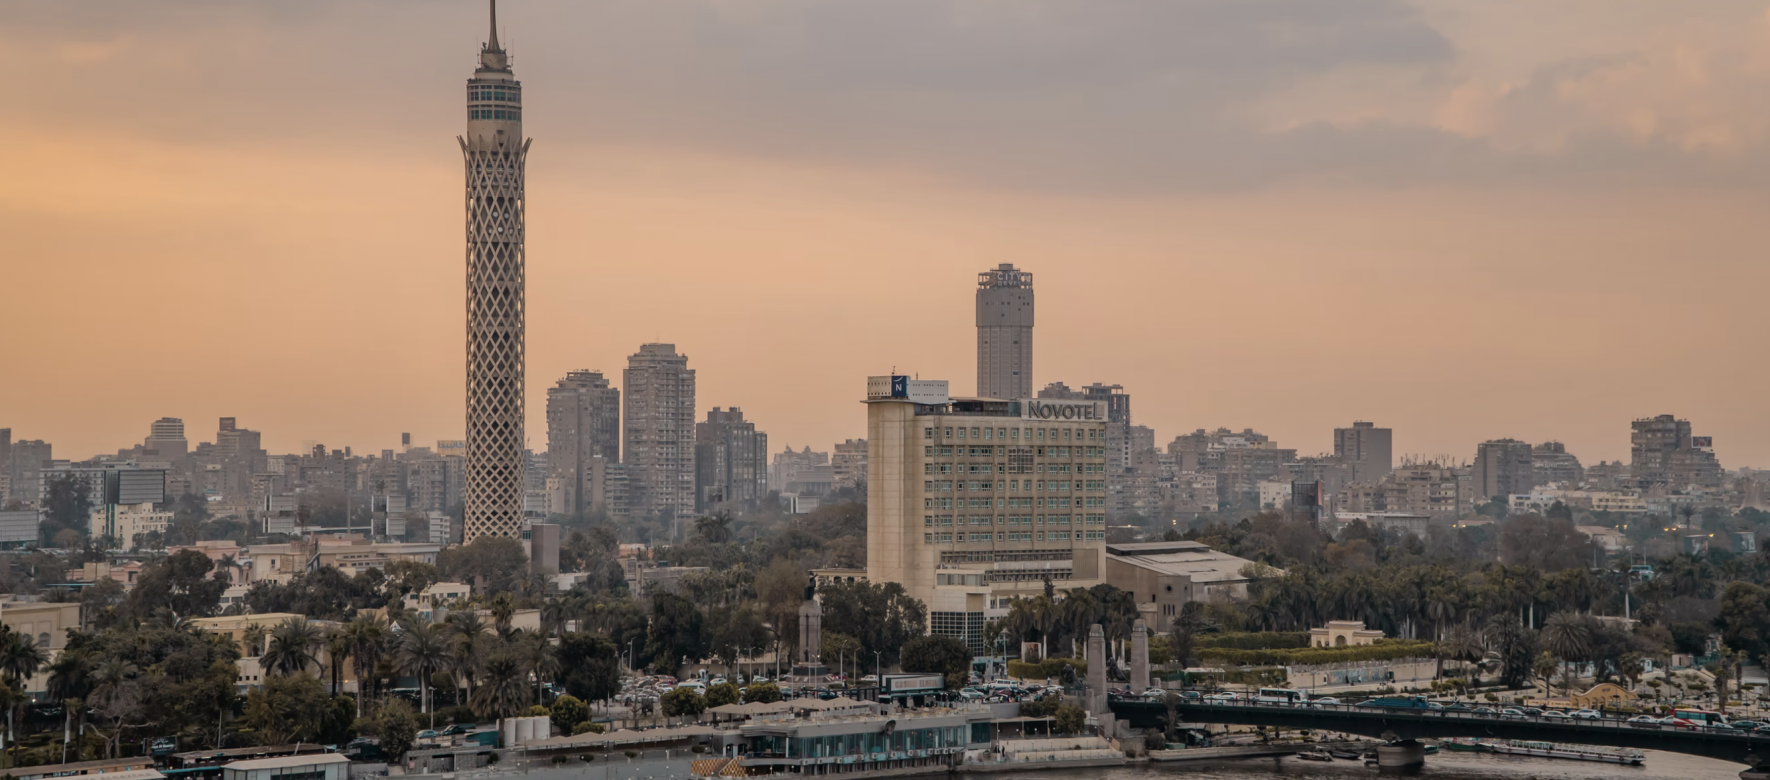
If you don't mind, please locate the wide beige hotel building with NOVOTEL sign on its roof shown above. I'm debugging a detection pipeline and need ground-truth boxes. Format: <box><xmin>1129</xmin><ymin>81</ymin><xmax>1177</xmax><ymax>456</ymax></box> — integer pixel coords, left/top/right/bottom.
<box><xmin>866</xmin><ymin>377</ymin><xmax>1106</xmax><ymax>654</ymax></box>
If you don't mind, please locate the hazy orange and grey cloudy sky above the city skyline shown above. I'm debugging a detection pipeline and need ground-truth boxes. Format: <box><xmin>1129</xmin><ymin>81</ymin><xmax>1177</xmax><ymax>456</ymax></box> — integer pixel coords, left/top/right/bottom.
<box><xmin>0</xmin><ymin>0</ymin><xmax>1770</xmax><ymax>469</ymax></box>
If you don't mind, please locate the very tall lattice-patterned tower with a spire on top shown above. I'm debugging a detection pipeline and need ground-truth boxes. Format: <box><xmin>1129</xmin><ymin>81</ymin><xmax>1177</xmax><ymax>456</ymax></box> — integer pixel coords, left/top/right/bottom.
<box><xmin>458</xmin><ymin>0</ymin><xmax>529</xmax><ymax>543</ymax></box>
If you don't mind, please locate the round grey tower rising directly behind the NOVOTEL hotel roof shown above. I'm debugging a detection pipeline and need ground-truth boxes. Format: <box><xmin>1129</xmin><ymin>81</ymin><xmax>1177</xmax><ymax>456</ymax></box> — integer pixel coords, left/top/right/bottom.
<box><xmin>977</xmin><ymin>264</ymin><xmax>1032</xmax><ymax>400</ymax></box>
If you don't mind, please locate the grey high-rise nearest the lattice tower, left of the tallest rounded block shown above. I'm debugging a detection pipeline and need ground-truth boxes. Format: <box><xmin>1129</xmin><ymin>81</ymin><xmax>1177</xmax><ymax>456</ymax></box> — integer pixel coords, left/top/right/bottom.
<box><xmin>547</xmin><ymin>371</ymin><xmax>621</xmax><ymax>515</ymax></box>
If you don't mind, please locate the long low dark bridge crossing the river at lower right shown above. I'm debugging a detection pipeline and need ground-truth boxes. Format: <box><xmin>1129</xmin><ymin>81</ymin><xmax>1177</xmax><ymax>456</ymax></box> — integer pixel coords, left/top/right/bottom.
<box><xmin>1110</xmin><ymin>699</ymin><xmax>1770</xmax><ymax>764</ymax></box>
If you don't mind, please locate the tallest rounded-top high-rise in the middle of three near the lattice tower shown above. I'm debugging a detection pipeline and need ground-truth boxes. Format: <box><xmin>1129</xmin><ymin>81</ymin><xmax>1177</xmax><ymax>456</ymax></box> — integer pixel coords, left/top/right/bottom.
<box><xmin>621</xmin><ymin>343</ymin><xmax>694</xmax><ymax>520</ymax></box>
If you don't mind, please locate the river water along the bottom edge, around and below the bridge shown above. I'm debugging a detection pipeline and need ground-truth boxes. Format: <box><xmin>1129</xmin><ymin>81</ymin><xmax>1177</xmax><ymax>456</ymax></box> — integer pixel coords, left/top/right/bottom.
<box><xmin>977</xmin><ymin>750</ymin><xmax>1745</xmax><ymax>780</ymax></box>
